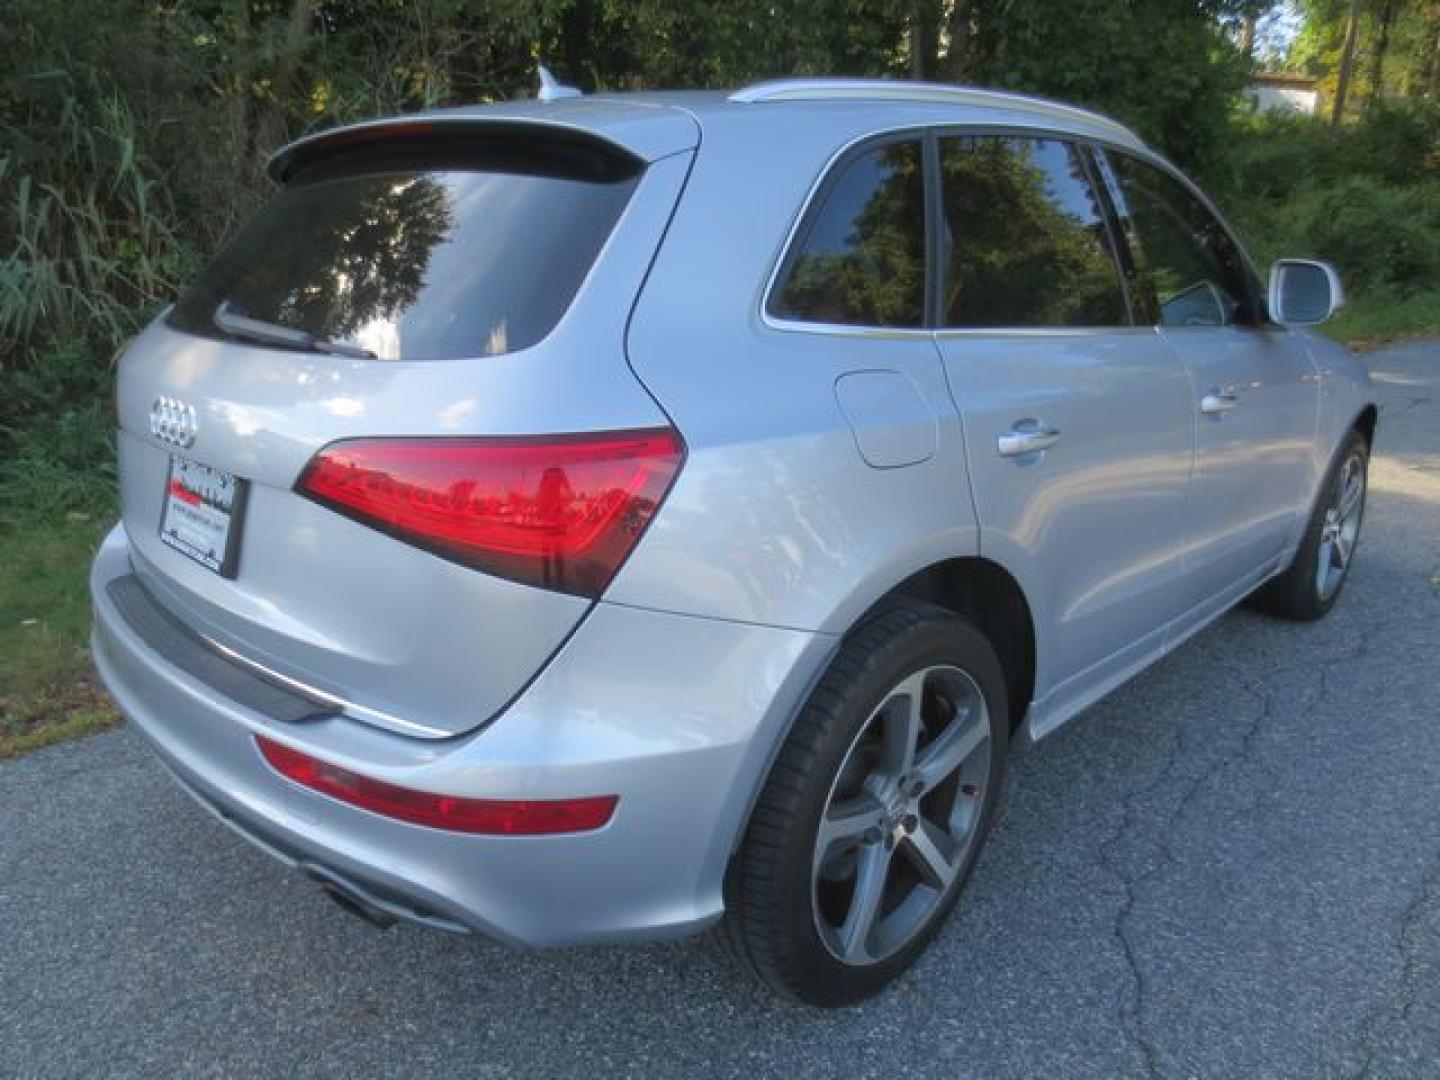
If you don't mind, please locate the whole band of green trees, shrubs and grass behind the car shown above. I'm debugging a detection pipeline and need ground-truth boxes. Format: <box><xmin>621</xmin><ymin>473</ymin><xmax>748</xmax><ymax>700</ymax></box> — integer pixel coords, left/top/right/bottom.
<box><xmin>0</xmin><ymin>0</ymin><xmax>1440</xmax><ymax>756</ymax></box>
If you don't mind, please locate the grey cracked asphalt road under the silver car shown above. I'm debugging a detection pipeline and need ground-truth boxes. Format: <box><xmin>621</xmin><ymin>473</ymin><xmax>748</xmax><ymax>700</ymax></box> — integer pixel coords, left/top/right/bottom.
<box><xmin>0</xmin><ymin>343</ymin><xmax>1440</xmax><ymax>1077</ymax></box>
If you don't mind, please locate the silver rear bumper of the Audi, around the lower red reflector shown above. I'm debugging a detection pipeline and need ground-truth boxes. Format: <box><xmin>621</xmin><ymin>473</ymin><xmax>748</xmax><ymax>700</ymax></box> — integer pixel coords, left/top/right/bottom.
<box><xmin>91</xmin><ymin>527</ymin><xmax>834</xmax><ymax>945</ymax></box>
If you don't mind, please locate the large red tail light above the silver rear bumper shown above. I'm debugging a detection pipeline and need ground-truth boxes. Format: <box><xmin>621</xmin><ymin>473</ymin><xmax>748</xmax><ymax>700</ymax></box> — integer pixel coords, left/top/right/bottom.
<box><xmin>295</xmin><ymin>428</ymin><xmax>685</xmax><ymax>596</ymax></box>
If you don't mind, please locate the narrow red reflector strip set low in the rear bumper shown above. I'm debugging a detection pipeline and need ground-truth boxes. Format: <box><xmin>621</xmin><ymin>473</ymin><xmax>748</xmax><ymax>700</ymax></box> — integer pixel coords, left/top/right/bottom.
<box><xmin>255</xmin><ymin>734</ymin><xmax>619</xmax><ymax>837</ymax></box>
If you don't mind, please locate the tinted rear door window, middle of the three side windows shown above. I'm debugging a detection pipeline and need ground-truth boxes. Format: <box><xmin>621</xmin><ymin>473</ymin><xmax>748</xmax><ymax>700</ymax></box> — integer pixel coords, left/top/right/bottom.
<box><xmin>940</xmin><ymin>135</ymin><xmax>1129</xmax><ymax>327</ymax></box>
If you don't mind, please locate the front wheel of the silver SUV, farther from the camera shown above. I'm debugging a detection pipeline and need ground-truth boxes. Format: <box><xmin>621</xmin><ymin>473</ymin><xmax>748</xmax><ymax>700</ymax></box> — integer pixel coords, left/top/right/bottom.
<box><xmin>1251</xmin><ymin>431</ymin><xmax>1369</xmax><ymax>619</ymax></box>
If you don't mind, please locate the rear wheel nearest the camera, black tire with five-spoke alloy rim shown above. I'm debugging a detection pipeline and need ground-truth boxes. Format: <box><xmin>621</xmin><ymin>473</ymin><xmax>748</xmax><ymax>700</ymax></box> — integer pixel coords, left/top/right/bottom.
<box><xmin>724</xmin><ymin>603</ymin><xmax>1008</xmax><ymax>1005</ymax></box>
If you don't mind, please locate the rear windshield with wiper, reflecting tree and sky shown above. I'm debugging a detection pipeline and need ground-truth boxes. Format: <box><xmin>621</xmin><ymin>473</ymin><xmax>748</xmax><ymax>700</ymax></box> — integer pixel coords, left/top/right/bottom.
<box><xmin>168</xmin><ymin>166</ymin><xmax>638</xmax><ymax>360</ymax></box>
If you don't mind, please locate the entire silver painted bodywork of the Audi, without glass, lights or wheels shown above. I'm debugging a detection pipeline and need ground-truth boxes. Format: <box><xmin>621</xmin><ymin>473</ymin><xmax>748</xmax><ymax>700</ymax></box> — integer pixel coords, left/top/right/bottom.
<box><xmin>92</xmin><ymin>94</ymin><xmax>1372</xmax><ymax>945</ymax></box>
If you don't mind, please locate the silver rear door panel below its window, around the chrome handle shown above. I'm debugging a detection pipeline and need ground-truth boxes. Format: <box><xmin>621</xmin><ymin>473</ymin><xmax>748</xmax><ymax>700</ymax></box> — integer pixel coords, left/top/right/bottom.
<box><xmin>940</xmin><ymin>328</ymin><xmax>1194</xmax><ymax>728</ymax></box>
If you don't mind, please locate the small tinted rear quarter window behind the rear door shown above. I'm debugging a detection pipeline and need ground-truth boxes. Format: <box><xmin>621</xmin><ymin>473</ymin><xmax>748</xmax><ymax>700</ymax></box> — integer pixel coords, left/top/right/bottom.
<box><xmin>770</xmin><ymin>143</ymin><xmax>924</xmax><ymax>327</ymax></box>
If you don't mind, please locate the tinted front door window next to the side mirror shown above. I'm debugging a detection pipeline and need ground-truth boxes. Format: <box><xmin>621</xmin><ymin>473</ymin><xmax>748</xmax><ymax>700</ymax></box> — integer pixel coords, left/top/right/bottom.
<box><xmin>1102</xmin><ymin>153</ymin><xmax>1250</xmax><ymax>327</ymax></box>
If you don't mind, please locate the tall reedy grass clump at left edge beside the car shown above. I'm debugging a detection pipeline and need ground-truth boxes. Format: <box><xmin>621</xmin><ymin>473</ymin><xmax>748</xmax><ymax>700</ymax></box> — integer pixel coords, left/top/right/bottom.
<box><xmin>0</xmin><ymin>73</ymin><xmax>190</xmax><ymax>528</ymax></box>
